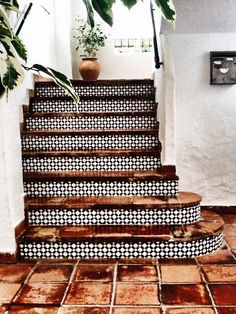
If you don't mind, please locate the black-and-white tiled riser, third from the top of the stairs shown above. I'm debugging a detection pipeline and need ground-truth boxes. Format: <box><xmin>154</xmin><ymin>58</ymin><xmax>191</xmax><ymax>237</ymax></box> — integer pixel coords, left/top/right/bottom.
<box><xmin>25</xmin><ymin>115</ymin><xmax>157</xmax><ymax>130</ymax></box>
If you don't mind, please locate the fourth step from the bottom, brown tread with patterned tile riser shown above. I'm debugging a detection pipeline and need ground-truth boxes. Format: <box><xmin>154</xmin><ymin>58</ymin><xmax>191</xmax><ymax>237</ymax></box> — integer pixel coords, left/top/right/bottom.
<box><xmin>22</xmin><ymin>150</ymin><xmax>161</xmax><ymax>172</ymax></box>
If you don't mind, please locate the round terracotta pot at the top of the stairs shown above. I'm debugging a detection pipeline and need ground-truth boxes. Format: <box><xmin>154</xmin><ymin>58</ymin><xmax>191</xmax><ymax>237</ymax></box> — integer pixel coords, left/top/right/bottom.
<box><xmin>79</xmin><ymin>58</ymin><xmax>101</xmax><ymax>82</ymax></box>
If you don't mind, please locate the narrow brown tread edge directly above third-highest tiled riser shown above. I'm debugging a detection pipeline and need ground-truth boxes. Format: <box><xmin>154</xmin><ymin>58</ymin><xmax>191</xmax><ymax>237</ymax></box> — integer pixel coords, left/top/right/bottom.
<box><xmin>24</xmin><ymin>110</ymin><xmax>156</xmax><ymax>118</ymax></box>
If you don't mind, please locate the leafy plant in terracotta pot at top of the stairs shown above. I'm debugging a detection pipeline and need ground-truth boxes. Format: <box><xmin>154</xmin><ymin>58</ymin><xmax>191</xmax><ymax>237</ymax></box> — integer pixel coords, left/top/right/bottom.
<box><xmin>73</xmin><ymin>18</ymin><xmax>107</xmax><ymax>81</ymax></box>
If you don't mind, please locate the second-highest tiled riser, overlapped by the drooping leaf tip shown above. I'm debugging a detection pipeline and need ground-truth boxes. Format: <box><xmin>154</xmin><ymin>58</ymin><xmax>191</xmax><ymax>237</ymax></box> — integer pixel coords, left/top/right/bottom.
<box><xmin>31</xmin><ymin>98</ymin><xmax>156</xmax><ymax>113</ymax></box>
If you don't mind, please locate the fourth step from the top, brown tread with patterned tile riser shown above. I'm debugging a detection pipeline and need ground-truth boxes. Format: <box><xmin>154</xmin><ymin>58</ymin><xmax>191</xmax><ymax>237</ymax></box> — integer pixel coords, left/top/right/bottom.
<box><xmin>21</xmin><ymin>129</ymin><xmax>160</xmax><ymax>151</ymax></box>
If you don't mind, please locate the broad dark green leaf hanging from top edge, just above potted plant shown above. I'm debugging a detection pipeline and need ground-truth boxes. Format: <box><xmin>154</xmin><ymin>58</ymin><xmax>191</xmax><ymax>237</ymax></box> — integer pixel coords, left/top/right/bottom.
<box><xmin>92</xmin><ymin>0</ymin><xmax>115</xmax><ymax>26</ymax></box>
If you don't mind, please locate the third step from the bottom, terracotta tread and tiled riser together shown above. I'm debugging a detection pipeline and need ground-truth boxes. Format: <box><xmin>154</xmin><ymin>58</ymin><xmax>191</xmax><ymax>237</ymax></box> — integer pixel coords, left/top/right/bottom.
<box><xmin>24</xmin><ymin>170</ymin><xmax>178</xmax><ymax>197</ymax></box>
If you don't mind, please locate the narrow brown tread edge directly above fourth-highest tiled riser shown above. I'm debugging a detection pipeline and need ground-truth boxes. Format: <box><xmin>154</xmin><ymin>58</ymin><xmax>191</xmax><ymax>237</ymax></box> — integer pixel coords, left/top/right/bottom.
<box><xmin>21</xmin><ymin>128</ymin><xmax>158</xmax><ymax>136</ymax></box>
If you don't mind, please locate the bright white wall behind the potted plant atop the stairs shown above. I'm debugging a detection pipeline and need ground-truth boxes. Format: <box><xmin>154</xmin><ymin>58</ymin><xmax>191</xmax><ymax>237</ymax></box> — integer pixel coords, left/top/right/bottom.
<box><xmin>71</xmin><ymin>0</ymin><xmax>157</xmax><ymax>79</ymax></box>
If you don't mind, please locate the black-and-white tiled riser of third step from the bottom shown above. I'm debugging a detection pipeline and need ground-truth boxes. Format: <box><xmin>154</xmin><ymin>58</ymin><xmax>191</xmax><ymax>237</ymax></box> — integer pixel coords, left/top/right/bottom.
<box><xmin>24</xmin><ymin>178</ymin><xmax>178</xmax><ymax>197</ymax></box>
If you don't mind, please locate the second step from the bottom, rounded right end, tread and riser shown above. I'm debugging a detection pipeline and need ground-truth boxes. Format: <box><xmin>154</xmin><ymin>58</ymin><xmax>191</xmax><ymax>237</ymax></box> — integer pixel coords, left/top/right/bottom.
<box><xmin>27</xmin><ymin>192</ymin><xmax>201</xmax><ymax>226</ymax></box>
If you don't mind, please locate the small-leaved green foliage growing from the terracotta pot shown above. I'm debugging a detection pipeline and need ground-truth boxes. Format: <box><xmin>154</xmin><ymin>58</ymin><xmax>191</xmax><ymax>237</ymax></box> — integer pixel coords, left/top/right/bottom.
<box><xmin>73</xmin><ymin>18</ymin><xmax>107</xmax><ymax>58</ymax></box>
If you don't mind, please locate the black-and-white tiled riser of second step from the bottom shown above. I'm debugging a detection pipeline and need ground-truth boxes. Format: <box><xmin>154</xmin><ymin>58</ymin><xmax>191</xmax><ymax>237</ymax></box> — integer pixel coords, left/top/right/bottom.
<box><xmin>28</xmin><ymin>205</ymin><xmax>201</xmax><ymax>226</ymax></box>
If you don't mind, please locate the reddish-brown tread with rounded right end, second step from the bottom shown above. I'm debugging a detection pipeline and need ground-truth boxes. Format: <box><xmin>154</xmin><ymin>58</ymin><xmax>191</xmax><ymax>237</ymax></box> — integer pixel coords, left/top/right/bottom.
<box><xmin>27</xmin><ymin>192</ymin><xmax>202</xmax><ymax>209</ymax></box>
